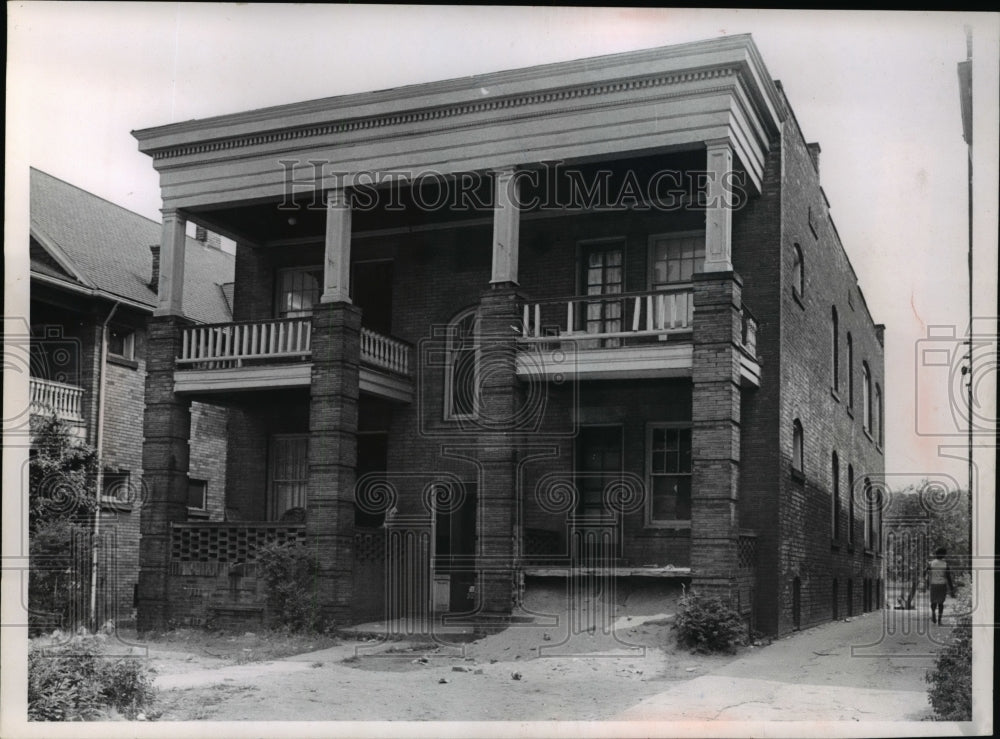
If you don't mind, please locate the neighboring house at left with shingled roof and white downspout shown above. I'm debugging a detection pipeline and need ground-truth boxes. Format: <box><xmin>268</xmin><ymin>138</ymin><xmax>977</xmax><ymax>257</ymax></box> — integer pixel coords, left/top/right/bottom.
<box><xmin>30</xmin><ymin>169</ymin><xmax>234</xmax><ymax>621</ymax></box>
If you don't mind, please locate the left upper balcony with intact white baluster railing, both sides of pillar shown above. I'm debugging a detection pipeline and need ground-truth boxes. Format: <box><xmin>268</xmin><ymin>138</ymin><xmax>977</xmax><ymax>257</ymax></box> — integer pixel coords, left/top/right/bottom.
<box><xmin>174</xmin><ymin>317</ymin><xmax>413</xmax><ymax>403</ymax></box>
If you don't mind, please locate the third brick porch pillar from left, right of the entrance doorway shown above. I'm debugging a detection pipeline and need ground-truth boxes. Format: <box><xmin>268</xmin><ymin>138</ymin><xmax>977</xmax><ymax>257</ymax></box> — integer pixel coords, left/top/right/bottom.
<box><xmin>471</xmin><ymin>282</ymin><xmax>524</xmax><ymax>615</ymax></box>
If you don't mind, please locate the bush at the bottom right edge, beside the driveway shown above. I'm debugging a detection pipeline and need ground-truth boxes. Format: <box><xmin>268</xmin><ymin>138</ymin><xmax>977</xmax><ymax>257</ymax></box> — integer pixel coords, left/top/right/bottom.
<box><xmin>926</xmin><ymin>592</ymin><xmax>972</xmax><ymax>721</ymax></box>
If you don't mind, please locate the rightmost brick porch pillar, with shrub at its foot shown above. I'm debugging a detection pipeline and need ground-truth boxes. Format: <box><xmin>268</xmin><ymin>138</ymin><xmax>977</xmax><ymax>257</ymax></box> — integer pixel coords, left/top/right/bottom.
<box><xmin>691</xmin><ymin>272</ymin><xmax>745</xmax><ymax>605</ymax></box>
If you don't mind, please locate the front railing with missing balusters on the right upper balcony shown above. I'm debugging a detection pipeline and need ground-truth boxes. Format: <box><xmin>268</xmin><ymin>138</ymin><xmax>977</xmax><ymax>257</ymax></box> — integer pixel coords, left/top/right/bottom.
<box><xmin>521</xmin><ymin>287</ymin><xmax>694</xmax><ymax>342</ymax></box>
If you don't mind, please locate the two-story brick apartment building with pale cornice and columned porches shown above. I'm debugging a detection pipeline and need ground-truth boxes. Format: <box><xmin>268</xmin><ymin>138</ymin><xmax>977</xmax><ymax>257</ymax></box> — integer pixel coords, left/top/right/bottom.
<box><xmin>134</xmin><ymin>36</ymin><xmax>884</xmax><ymax>634</ymax></box>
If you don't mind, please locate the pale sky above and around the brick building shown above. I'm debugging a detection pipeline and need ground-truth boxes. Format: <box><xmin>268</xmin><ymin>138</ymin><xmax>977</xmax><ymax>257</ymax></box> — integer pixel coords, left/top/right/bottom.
<box><xmin>5</xmin><ymin>2</ymin><xmax>1000</xmax><ymax>494</ymax></box>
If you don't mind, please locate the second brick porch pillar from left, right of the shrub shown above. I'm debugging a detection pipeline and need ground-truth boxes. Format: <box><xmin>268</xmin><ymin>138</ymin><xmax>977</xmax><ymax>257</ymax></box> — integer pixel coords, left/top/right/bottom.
<box><xmin>306</xmin><ymin>301</ymin><xmax>366</xmax><ymax>623</ymax></box>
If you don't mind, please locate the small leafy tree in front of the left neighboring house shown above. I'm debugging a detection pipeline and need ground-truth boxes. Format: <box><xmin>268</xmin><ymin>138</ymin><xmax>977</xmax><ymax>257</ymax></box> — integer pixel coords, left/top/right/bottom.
<box><xmin>28</xmin><ymin>416</ymin><xmax>97</xmax><ymax>634</ymax></box>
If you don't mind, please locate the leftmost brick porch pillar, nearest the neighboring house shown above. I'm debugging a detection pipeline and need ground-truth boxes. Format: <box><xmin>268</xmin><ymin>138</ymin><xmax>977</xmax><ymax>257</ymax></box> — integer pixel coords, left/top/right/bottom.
<box><xmin>136</xmin><ymin>316</ymin><xmax>191</xmax><ymax>632</ymax></box>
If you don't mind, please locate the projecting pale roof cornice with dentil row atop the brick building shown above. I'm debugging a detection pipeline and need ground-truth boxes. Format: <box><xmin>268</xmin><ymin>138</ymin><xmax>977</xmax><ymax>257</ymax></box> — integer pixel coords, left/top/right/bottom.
<box><xmin>133</xmin><ymin>35</ymin><xmax>783</xmax><ymax>168</ymax></box>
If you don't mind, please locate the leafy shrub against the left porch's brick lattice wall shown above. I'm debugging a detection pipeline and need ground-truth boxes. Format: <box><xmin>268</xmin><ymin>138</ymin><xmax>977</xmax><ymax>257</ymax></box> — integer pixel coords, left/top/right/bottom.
<box><xmin>257</xmin><ymin>543</ymin><xmax>322</xmax><ymax>631</ymax></box>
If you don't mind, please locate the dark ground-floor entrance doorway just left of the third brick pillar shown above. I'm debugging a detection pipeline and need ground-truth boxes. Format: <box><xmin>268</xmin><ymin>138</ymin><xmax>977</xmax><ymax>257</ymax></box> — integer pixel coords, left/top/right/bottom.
<box><xmin>434</xmin><ymin>483</ymin><xmax>476</xmax><ymax>613</ymax></box>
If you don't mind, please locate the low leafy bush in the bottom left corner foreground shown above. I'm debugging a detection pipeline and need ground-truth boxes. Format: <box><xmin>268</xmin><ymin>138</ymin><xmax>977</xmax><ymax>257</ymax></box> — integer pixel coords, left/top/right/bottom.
<box><xmin>28</xmin><ymin>636</ymin><xmax>155</xmax><ymax>721</ymax></box>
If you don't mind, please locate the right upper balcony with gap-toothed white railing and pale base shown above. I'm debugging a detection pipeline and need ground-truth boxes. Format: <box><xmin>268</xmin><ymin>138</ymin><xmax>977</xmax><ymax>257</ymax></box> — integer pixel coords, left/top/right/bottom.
<box><xmin>517</xmin><ymin>287</ymin><xmax>760</xmax><ymax>387</ymax></box>
